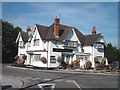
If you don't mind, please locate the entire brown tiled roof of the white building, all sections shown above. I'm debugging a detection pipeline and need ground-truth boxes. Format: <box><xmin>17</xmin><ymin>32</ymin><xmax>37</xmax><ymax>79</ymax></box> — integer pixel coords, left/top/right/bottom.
<box><xmin>21</xmin><ymin>23</ymin><xmax>101</xmax><ymax>45</ymax></box>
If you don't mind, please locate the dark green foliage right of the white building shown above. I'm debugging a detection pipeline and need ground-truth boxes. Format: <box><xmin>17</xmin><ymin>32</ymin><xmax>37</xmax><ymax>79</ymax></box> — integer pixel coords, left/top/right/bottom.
<box><xmin>105</xmin><ymin>43</ymin><xmax>120</xmax><ymax>63</ymax></box>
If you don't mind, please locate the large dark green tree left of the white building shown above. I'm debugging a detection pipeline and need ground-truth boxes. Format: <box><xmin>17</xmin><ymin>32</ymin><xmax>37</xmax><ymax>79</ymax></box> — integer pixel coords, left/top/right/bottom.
<box><xmin>2</xmin><ymin>20</ymin><xmax>21</xmax><ymax>62</ymax></box>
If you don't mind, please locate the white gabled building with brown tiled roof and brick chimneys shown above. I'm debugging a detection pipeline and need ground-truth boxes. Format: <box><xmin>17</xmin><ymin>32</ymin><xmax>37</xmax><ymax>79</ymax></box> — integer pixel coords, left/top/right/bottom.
<box><xmin>16</xmin><ymin>17</ymin><xmax>106</xmax><ymax>68</ymax></box>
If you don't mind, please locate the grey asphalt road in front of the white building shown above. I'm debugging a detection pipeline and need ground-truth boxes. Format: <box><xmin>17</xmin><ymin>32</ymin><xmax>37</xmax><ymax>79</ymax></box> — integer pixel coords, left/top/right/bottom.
<box><xmin>2</xmin><ymin>64</ymin><xmax>118</xmax><ymax>90</ymax></box>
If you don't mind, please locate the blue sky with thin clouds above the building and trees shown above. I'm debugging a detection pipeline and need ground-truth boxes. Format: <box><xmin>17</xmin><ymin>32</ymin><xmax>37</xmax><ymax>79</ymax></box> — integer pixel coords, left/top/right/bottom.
<box><xmin>2</xmin><ymin>2</ymin><xmax>118</xmax><ymax>47</ymax></box>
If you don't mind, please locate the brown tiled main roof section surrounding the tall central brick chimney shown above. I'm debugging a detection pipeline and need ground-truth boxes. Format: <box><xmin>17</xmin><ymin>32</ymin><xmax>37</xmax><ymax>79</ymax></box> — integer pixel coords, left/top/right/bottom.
<box><xmin>36</xmin><ymin>23</ymin><xmax>85</xmax><ymax>43</ymax></box>
